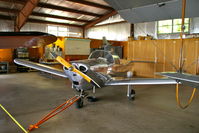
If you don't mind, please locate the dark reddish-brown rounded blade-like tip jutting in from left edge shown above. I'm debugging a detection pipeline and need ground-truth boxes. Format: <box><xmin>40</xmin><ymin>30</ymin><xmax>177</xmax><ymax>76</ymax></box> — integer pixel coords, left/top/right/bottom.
<box><xmin>0</xmin><ymin>32</ymin><xmax>57</xmax><ymax>49</ymax></box>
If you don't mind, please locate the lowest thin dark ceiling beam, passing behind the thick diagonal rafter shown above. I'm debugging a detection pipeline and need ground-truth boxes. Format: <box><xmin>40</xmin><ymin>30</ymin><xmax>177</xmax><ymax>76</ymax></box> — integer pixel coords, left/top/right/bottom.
<box><xmin>0</xmin><ymin>15</ymin><xmax>82</xmax><ymax>28</ymax></box>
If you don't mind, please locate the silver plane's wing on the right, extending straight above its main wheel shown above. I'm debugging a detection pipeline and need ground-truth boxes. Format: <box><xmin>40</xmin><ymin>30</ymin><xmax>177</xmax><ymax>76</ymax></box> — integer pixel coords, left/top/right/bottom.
<box><xmin>105</xmin><ymin>78</ymin><xmax>177</xmax><ymax>85</ymax></box>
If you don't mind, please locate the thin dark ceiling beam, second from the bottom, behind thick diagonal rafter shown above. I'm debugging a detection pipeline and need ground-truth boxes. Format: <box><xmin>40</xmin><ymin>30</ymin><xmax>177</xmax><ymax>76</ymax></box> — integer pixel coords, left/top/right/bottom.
<box><xmin>0</xmin><ymin>7</ymin><xmax>91</xmax><ymax>23</ymax></box>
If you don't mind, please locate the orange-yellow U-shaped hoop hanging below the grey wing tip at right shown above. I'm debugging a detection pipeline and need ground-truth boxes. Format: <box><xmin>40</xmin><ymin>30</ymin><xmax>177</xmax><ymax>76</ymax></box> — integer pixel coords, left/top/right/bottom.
<box><xmin>176</xmin><ymin>84</ymin><xmax>196</xmax><ymax>109</ymax></box>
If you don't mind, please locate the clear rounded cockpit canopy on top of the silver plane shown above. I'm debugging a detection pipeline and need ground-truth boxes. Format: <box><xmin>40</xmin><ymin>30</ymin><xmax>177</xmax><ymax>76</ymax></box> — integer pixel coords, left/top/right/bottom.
<box><xmin>88</xmin><ymin>50</ymin><xmax>120</xmax><ymax>64</ymax></box>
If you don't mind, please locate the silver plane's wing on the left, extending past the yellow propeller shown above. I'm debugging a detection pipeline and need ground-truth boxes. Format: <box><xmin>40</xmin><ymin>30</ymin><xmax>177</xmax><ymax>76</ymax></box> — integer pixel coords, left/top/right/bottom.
<box><xmin>14</xmin><ymin>59</ymin><xmax>67</xmax><ymax>78</ymax></box>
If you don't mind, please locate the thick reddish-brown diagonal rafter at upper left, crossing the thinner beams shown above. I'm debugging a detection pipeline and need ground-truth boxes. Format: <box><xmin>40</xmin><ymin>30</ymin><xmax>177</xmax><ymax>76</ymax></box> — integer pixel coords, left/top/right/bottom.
<box><xmin>14</xmin><ymin>0</ymin><xmax>39</xmax><ymax>32</ymax></box>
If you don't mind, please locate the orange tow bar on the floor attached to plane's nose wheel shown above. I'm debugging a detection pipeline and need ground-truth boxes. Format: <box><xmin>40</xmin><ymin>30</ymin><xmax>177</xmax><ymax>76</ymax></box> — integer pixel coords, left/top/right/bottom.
<box><xmin>28</xmin><ymin>96</ymin><xmax>81</xmax><ymax>131</ymax></box>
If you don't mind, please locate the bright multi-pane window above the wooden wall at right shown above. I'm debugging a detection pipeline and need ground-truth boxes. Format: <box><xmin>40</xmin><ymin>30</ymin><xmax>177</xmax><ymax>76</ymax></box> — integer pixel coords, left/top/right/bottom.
<box><xmin>158</xmin><ymin>18</ymin><xmax>190</xmax><ymax>34</ymax></box>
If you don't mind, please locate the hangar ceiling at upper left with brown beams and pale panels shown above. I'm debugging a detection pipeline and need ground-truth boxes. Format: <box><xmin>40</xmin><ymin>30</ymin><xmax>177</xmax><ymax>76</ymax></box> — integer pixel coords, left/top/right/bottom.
<box><xmin>0</xmin><ymin>0</ymin><xmax>117</xmax><ymax>31</ymax></box>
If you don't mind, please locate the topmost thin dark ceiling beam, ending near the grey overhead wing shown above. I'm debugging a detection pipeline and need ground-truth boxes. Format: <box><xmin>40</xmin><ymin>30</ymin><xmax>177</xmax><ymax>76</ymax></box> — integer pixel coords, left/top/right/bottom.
<box><xmin>66</xmin><ymin>0</ymin><xmax>114</xmax><ymax>10</ymax></box>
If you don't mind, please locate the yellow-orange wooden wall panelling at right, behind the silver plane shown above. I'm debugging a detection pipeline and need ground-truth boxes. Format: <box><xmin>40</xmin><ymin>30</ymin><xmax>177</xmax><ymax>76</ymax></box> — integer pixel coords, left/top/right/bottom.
<box><xmin>127</xmin><ymin>39</ymin><xmax>199</xmax><ymax>77</ymax></box>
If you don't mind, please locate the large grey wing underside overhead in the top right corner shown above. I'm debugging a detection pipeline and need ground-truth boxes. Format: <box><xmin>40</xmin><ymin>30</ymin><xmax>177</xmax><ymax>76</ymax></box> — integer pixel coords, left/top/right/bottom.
<box><xmin>105</xmin><ymin>0</ymin><xmax>199</xmax><ymax>24</ymax></box>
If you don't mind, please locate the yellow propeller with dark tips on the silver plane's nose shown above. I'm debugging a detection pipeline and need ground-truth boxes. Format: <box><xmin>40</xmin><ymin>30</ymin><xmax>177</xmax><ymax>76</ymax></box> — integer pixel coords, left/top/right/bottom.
<box><xmin>51</xmin><ymin>52</ymin><xmax>101</xmax><ymax>88</ymax></box>
